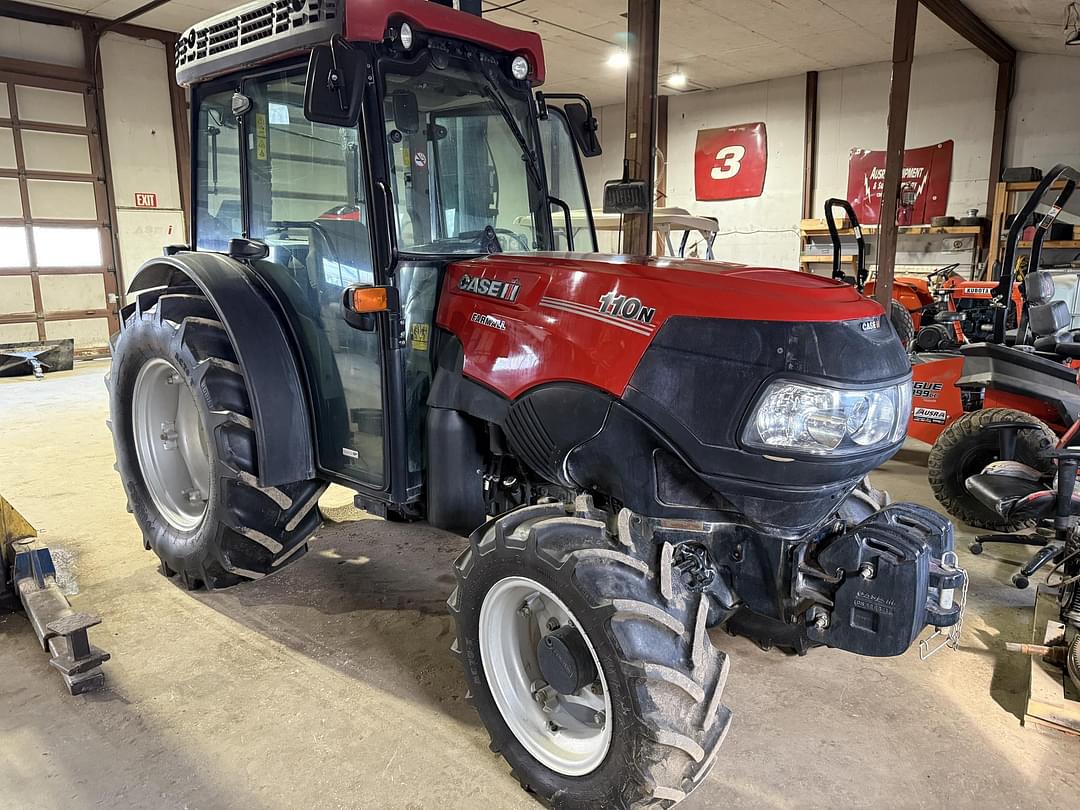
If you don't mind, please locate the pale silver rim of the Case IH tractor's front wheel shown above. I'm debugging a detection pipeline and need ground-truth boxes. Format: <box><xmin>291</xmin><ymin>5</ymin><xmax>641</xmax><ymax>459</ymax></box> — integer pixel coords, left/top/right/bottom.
<box><xmin>480</xmin><ymin>577</ymin><xmax>613</xmax><ymax>777</ymax></box>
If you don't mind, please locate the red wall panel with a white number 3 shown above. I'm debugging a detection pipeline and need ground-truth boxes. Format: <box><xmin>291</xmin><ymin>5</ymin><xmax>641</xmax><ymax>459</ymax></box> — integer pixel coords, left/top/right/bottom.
<box><xmin>693</xmin><ymin>121</ymin><xmax>769</xmax><ymax>201</ymax></box>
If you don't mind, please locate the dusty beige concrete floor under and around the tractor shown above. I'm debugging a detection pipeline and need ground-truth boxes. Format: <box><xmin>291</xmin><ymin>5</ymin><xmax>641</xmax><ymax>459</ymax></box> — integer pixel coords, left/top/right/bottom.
<box><xmin>0</xmin><ymin>362</ymin><xmax>1080</xmax><ymax>810</ymax></box>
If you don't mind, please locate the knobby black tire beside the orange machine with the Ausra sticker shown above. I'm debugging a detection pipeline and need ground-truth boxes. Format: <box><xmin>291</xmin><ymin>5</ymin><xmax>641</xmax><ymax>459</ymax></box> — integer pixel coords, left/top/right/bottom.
<box><xmin>928</xmin><ymin>408</ymin><xmax>1057</xmax><ymax>531</ymax></box>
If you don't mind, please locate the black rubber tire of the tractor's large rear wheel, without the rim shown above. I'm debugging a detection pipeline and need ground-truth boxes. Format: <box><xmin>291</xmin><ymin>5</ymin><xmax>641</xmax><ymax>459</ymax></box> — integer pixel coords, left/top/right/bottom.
<box><xmin>106</xmin><ymin>289</ymin><xmax>326</xmax><ymax>589</ymax></box>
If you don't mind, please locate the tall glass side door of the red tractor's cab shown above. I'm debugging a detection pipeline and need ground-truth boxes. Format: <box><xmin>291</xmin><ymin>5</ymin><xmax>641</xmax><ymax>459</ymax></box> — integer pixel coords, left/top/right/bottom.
<box><xmin>241</xmin><ymin>65</ymin><xmax>390</xmax><ymax>490</ymax></box>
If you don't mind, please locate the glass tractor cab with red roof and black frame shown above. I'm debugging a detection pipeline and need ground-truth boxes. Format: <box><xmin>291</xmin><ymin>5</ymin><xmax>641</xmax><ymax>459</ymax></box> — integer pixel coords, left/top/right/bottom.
<box><xmin>177</xmin><ymin>0</ymin><xmax>599</xmax><ymax>511</ymax></box>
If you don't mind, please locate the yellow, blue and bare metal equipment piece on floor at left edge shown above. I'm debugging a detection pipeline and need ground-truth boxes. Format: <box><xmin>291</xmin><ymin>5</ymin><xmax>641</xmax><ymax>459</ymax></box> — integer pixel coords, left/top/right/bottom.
<box><xmin>0</xmin><ymin>496</ymin><xmax>110</xmax><ymax>694</ymax></box>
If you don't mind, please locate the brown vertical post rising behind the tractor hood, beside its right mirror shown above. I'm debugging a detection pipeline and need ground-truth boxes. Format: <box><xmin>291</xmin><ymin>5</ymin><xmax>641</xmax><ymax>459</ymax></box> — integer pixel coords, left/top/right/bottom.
<box><xmin>623</xmin><ymin>0</ymin><xmax>660</xmax><ymax>256</ymax></box>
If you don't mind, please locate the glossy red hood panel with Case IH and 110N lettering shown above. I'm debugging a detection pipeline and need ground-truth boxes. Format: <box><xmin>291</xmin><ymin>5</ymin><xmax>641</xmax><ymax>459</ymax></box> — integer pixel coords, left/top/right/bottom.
<box><xmin>437</xmin><ymin>253</ymin><xmax>882</xmax><ymax>399</ymax></box>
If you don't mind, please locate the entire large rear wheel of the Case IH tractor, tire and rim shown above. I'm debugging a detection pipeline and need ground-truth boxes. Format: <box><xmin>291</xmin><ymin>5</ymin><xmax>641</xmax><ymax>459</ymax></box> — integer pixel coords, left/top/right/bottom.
<box><xmin>106</xmin><ymin>289</ymin><xmax>325</xmax><ymax>589</ymax></box>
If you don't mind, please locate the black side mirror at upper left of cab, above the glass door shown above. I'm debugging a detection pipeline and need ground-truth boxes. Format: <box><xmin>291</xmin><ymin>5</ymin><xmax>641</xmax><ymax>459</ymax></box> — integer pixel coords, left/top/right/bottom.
<box><xmin>303</xmin><ymin>42</ymin><xmax>369</xmax><ymax>126</ymax></box>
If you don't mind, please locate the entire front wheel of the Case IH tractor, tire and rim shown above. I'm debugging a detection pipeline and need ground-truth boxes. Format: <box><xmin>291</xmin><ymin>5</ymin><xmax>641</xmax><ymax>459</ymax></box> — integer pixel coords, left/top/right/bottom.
<box><xmin>448</xmin><ymin>497</ymin><xmax>730</xmax><ymax>810</ymax></box>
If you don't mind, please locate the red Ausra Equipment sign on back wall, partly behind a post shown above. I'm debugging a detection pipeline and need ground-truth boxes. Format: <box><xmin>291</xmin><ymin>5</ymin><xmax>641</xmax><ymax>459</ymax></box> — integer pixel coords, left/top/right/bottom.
<box><xmin>848</xmin><ymin>140</ymin><xmax>953</xmax><ymax>225</ymax></box>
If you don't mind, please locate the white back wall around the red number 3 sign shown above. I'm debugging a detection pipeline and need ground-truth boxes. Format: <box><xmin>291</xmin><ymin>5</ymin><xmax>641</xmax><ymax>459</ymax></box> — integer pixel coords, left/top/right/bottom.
<box><xmin>586</xmin><ymin>50</ymin><xmax>1080</xmax><ymax>267</ymax></box>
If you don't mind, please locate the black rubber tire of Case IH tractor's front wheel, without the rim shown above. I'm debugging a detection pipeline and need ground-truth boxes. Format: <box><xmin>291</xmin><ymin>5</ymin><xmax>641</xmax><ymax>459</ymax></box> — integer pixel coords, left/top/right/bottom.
<box><xmin>448</xmin><ymin>497</ymin><xmax>731</xmax><ymax>810</ymax></box>
